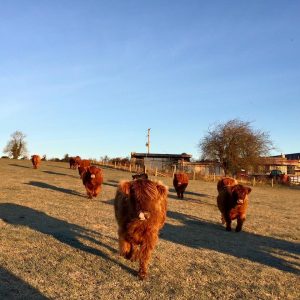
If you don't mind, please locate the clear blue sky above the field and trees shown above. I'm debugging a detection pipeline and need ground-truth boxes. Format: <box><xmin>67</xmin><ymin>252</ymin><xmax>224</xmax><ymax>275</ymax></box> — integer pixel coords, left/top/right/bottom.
<box><xmin>0</xmin><ymin>0</ymin><xmax>300</xmax><ymax>159</ymax></box>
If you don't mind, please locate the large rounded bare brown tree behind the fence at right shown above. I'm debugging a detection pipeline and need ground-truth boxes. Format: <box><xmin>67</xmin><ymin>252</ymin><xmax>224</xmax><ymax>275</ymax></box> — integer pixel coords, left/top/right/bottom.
<box><xmin>199</xmin><ymin>119</ymin><xmax>273</xmax><ymax>175</ymax></box>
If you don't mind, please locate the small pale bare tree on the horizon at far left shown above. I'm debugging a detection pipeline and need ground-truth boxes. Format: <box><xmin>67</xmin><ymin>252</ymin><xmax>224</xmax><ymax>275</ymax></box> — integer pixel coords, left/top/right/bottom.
<box><xmin>3</xmin><ymin>131</ymin><xmax>28</xmax><ymax>159</ymax></box>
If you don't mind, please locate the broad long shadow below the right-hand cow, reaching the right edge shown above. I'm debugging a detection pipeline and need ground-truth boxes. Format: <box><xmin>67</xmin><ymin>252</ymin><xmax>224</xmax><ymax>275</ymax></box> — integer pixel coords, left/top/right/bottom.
<box><xmin>161</xmin><ymin>211</ymin><xmax>300</xmax><ymax>274</ymax></box>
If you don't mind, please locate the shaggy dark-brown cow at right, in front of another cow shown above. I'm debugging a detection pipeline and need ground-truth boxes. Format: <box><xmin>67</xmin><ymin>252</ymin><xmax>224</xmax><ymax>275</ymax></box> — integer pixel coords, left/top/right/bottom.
<box><xmin>217</xmin><ymin>184</ymin><xmax>251</xmax><ymax>232</ymax></box>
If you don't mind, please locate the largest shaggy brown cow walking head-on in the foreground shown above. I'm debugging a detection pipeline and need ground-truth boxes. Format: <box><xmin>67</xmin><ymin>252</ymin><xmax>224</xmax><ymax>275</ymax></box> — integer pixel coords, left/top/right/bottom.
<box><xmin>114</xmin><ymin>179</ymin><xmax>168</xmax><ymax>279</ymax></box>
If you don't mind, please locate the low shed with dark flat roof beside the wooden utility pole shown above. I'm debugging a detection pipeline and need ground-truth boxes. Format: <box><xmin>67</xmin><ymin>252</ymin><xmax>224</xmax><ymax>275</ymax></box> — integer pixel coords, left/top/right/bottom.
<box><xmin>131</xmin><ymin>152</ymin><xmax>192</xmax><ymax>171</ymax></box>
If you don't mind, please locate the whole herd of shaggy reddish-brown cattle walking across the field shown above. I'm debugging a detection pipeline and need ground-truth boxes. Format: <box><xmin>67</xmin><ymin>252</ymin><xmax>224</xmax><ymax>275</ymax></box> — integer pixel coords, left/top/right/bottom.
<box><xmin>31</xmin><ymin>155</ymin><xmax>251</xmax><ymax>279</ymax></box>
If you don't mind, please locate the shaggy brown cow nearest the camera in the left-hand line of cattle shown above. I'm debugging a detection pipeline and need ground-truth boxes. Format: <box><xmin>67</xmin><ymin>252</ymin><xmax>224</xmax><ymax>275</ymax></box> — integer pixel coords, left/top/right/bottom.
<box><xmin>82</xmin><ymin>166</ymin><xmax>103</xmax><ymax>199</ymax></box>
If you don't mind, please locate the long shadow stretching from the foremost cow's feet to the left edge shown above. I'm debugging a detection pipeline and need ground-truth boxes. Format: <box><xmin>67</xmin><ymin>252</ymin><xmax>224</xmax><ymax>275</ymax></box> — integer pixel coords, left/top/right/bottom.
<box><xmin>0</xmin><ymin>203</ymin><xmax>136</xmax><ymax>275</ymax></box>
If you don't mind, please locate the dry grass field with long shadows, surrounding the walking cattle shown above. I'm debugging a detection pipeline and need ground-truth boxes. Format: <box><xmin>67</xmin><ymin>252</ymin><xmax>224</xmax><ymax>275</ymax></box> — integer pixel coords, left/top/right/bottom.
<box><xmin>0</xmin><ymin>159</ymin><xmax>300</xmax><ymax>299</ymax></box>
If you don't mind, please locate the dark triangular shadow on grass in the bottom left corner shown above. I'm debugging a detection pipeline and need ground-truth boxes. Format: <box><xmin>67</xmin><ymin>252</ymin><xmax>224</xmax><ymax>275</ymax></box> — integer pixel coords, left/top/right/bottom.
<box><xmin>0</xmin><ymin>267</ymin><xmax>48</xmax><ymax>300</ymax></box>
